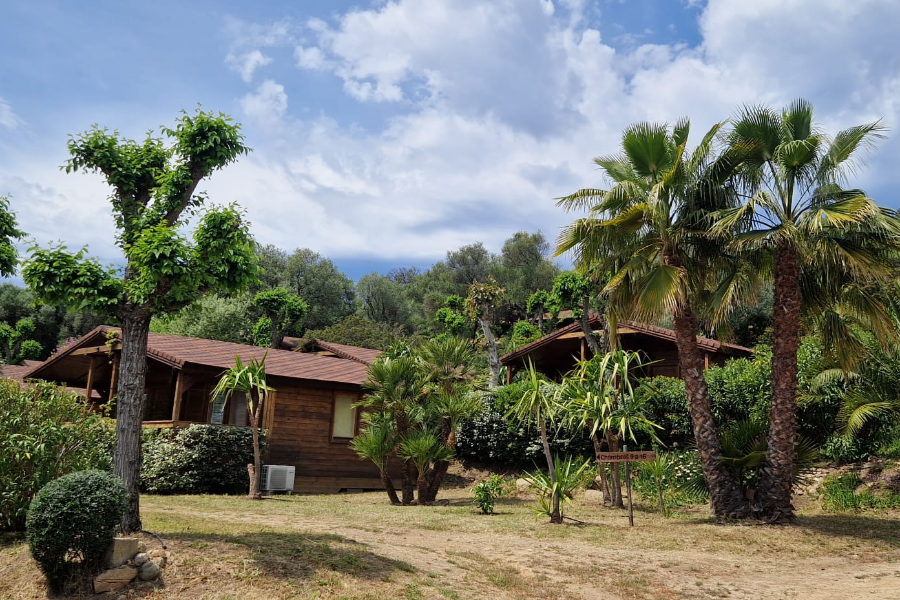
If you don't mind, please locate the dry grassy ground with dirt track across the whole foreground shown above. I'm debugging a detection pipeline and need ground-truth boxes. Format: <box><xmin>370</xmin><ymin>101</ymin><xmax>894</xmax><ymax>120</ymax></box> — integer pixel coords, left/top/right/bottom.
<box><xmin>0</xmin><ymin>489</ymin><xmax>900</xmax><ymax>600</ymax></box>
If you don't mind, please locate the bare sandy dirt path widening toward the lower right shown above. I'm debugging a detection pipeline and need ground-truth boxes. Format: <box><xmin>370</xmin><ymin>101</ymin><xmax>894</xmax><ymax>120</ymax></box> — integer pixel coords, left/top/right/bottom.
<box><xmin>148</xmin><ymin>508</ymin><xmax>900</xmax><ymax>600</ymax></box>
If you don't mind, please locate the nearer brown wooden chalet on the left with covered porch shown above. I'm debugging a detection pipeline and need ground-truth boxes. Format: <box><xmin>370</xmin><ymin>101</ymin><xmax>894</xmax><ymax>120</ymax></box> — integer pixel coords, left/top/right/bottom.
<box><xmin>21</xmin><ymin>326</ymin><xmax>383</xmax><ymax>492</ymax></box>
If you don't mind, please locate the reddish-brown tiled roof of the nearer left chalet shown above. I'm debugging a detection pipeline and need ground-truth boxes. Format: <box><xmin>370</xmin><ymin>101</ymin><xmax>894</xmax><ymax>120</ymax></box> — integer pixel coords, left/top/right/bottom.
<box><xmin>26</xmin><ymin>326</ymin><xmax>367</xmax><ymax>385</ymax></box>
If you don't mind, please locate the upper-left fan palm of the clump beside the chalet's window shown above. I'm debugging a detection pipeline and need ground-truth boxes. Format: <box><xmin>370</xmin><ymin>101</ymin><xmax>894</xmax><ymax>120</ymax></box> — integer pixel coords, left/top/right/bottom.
<box><xmin>359</xmin><ymin>355</ymin><xmax>425</xmax><ymax>505</ymax></box>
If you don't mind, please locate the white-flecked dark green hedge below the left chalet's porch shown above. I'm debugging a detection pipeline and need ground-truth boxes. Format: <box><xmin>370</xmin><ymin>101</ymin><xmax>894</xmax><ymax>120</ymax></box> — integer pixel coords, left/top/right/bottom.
<box><xmin>141</xmin><ymin>425</ymin><xmax>265</xmax><ymax>494</ymax></box>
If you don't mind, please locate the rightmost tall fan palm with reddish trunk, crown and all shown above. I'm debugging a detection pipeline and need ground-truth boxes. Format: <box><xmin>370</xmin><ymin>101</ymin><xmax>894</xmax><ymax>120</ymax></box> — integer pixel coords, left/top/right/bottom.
<box><xmin>714</xmin><ymin>100</ymin><xmax>898</xmax><ymax>521</ymax></box>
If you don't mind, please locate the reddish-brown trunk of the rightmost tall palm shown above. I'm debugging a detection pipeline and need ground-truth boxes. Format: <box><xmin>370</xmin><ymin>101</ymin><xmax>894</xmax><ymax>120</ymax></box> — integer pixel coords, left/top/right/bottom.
<box><xmin>755</xmin><ymin>245</ymin><xmax>801</xmax><ymax>522</ymax></box>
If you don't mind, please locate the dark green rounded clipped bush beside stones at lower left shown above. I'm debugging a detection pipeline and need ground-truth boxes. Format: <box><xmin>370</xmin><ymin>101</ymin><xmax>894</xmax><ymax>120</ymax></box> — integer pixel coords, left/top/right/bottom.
<box><xmin>26</xmin><ymin>470</ymin><xmax>127</xmax><ymax>590</ymax></box>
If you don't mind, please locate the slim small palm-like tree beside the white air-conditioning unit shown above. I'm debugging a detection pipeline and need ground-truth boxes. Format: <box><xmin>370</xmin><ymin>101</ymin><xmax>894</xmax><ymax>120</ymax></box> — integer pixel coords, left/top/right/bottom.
<box><xmin>212</xmin><ymin>351</ymin><xmax>273</xmax><ymax>500</ymax></box>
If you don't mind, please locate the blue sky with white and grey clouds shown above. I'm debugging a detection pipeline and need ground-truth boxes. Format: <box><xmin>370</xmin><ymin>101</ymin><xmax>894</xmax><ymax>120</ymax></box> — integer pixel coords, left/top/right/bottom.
<box><xmin>0</xmin><ymin>0</ymin><xmax>900</xmax><ymax>278</ymax></box>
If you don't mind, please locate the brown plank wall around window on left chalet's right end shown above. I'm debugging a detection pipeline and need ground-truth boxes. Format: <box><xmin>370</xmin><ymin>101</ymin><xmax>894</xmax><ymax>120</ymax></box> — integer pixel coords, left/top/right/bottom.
<box><xmin>266</xmin><ymin>384</ymin><xmax>381</xmax><ymax>492</ymax></box>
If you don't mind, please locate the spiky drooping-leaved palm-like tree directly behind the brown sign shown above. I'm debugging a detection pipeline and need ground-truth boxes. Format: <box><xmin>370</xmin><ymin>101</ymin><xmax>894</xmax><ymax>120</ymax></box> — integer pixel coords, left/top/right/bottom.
<box><xmin>561</xmin><ymin>349</ymin><xmax>659</xmax><ymax>508</ymax></box>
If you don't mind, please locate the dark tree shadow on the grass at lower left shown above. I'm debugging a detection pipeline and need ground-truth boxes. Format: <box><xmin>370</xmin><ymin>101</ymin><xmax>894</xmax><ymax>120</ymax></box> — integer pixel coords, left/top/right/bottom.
<box><xmin>167</xmin><ymin>531</ymin><xmax>415</xmax><ymax>580</ymax></box>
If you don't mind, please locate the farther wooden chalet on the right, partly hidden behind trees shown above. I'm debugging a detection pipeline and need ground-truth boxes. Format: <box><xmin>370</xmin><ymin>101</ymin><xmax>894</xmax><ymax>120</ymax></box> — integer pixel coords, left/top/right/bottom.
<box><xmin>500</xmin><ymin>315</ymin><xmax>753</xmax><ymax>382</ymax></box>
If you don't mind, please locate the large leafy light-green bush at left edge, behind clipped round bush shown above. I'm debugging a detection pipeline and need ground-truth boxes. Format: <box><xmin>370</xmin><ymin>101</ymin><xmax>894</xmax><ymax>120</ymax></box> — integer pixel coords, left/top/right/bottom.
<box><xmin>0</xmin><ymin>379</ymin><xmax>115</xmax><ymax>530</ymax></box>
